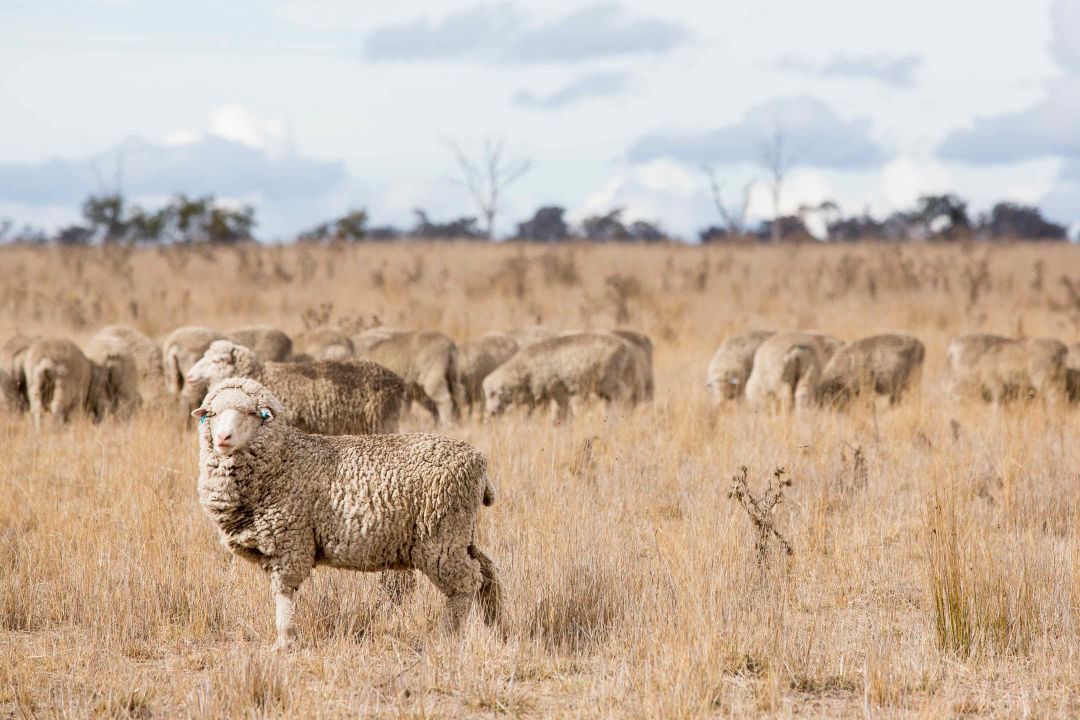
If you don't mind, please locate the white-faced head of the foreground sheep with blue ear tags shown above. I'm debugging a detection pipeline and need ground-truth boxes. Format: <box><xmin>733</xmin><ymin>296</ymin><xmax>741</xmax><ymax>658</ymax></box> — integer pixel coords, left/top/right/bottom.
<box><xmin>191</xmin><ymin>378</ymin><xmax>285</xmax><ymax>457</ymax></box>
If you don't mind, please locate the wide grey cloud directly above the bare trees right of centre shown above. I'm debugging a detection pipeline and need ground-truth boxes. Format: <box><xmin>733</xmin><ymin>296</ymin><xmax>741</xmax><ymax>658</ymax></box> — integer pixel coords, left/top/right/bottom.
<box><xmin>627</xmin><ymin>96</ymin><xmax>886</xmax><ymax>169</ymax></box>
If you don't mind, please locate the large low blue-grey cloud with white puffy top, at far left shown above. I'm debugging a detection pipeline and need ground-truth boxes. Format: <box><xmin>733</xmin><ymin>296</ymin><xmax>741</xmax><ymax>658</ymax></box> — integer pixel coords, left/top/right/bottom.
<box><xmin>0</xmin><ymin>107</ymin><xmax>347</xmax><ymax>234</ymax></box>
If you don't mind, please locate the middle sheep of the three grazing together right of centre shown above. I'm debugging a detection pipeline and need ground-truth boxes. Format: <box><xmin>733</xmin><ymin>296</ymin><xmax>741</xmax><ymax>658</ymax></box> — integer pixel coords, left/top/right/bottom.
<box><xmin>746</xmin><ymin>332</ymin><xmax>842</xmax><ymax>410</ymax></box>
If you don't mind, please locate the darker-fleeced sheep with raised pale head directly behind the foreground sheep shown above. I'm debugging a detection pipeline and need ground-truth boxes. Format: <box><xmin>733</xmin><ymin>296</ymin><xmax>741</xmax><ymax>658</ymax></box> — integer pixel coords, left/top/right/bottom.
<box><xmin>187</xmin><ymin>340</ymin><xmax>405</xmax><ymax>435</ymax></box>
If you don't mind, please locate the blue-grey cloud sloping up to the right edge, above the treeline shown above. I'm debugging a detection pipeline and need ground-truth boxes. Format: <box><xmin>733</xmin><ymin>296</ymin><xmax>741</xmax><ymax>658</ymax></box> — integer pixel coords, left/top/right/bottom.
<box><xmin>937</xmin><ymin>74</ymin><xmax>1080</xmax><ymax>164</ymax></box>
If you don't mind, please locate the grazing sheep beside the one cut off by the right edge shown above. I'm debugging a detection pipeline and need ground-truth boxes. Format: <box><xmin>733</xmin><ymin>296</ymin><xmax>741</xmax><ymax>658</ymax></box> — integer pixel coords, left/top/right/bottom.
<box><xmin>946</xmin><ymin>335</ymin><xmax>1068</xmax><ymax>405</ymax></box>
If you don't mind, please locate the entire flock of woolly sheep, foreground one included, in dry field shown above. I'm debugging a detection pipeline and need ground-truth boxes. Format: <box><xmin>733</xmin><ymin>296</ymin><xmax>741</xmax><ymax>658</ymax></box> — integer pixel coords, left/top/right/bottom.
<box><xmin>0</xmin><ymin>325</ymin><xmax>1080</xmax><ymax>647</ymax></box>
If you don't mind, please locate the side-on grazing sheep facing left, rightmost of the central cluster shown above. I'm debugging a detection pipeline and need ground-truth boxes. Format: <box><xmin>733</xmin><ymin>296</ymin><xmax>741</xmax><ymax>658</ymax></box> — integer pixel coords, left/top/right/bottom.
<box><xmin>483</xmin><ymin>332</ymin><xmax>644</xmax><ymax>420</ymax></box>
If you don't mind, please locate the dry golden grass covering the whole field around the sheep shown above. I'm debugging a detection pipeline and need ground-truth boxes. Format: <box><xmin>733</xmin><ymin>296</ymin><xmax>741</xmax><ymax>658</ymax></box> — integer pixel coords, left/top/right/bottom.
<box><xmin>0</xmin><ymin>244</ymin><xmax>1080</xmax><ymax>718</ymax></box>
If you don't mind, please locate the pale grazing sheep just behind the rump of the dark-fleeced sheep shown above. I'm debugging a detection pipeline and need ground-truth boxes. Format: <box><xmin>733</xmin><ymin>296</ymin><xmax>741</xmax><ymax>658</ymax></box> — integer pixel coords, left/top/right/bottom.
<box><xmin>353</xmin><ymin>328</ymin><xmax>464</xmax><ymax>424</ymax></box>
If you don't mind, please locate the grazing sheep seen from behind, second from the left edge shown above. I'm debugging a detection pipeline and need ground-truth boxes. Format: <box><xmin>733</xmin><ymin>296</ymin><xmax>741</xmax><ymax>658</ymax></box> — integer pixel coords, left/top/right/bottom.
<box><xmin>23</xmin><ymin>338</ymin><xmax>110</xmax><ymax>430</ymax></box>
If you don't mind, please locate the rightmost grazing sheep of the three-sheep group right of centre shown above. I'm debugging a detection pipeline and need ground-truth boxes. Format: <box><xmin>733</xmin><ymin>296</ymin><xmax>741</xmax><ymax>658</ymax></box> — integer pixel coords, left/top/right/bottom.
<box><xmin>808</xmin><ymin>335</ymin><xmax>927</xmax><ymax>409</ymax></box>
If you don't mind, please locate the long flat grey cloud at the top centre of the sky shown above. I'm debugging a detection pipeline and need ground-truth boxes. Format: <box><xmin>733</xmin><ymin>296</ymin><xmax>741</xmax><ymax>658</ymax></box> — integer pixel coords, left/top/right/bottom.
<box><xmin>364</xmin><ymin>2</ymin><xmax>690</xmax><ymax>64</ymax></box>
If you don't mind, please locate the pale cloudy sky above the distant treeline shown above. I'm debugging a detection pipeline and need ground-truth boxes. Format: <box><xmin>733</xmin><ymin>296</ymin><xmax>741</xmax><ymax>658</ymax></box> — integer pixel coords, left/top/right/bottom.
<box><xmin>0</xmin><ymin>0</ymin><xmax>1080</xmax><ymax>240</ymax></box>
